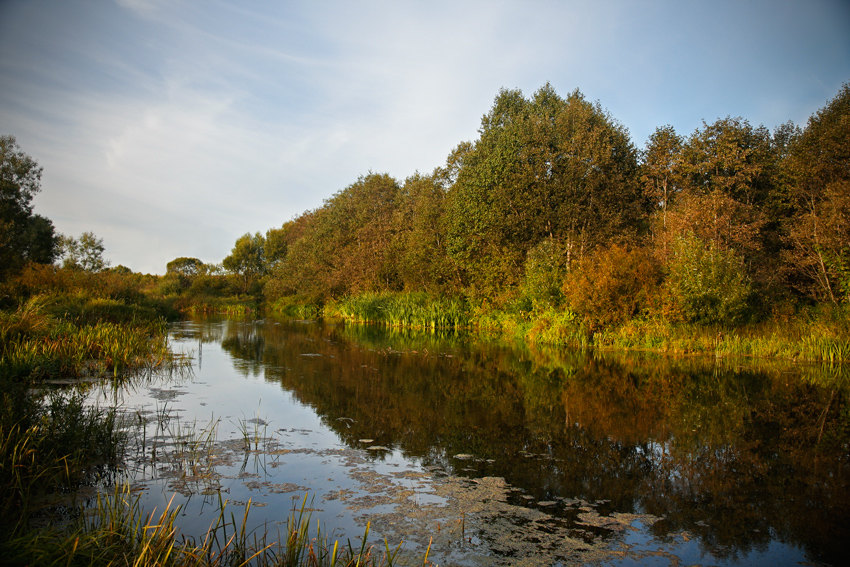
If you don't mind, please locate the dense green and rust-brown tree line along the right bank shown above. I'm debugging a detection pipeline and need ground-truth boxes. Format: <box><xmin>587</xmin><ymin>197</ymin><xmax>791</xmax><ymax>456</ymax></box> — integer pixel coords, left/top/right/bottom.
<box><xmin>212</xmin><ymin>84</ymin><xmax>850</xmax><ymax>323</ymax></box>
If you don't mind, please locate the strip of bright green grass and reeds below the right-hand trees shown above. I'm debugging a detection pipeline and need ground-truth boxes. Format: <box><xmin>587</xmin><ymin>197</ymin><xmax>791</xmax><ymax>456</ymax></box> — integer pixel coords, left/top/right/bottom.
<box><xmin>300</xmin><ymin>293</ymin><xmax>850</xmax><ymax>363</ymax></box>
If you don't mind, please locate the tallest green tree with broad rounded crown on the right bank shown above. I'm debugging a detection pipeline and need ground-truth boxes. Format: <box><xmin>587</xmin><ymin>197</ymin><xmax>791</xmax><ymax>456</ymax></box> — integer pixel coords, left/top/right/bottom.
<box><xmin>447</xmin><ymin>84</ymin><xmax>647</xmax><ymax>291</ymax></box>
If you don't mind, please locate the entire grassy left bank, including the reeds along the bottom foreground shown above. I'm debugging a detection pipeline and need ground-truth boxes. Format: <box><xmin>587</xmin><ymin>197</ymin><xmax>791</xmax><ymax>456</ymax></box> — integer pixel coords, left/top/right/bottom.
<box><xmin>0</xmin><ymin>269</ymin><xmax>410</xmax><ymax>567</ymax></box>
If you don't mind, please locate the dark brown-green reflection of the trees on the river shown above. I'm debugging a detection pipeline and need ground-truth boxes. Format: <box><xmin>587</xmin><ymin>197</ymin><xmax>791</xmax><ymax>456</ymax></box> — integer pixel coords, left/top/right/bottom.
<box><xmin>209</xmin><ymin>321</ymin><xmax>850</xmax><ymax>563</ymax></box>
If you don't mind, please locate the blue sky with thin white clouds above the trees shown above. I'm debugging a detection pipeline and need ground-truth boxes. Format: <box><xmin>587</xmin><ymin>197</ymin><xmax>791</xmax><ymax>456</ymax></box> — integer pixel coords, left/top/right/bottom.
<box><xmin>0</xmin><ymin>0</ymin><xmax>850</xmax><ymax>274</ymax></box>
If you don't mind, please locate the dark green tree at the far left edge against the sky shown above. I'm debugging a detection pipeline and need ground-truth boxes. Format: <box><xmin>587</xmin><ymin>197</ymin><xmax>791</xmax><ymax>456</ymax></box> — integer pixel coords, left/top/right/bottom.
<box><xmin>0</xmin><ymin>136</ymin><xmax>59</xmax><ymax>278</ymax></box>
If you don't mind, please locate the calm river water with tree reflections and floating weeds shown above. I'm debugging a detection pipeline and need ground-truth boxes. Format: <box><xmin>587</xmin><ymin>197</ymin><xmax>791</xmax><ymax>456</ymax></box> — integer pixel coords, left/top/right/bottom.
<box><xmin>84</xmin><ymin>319</ymin><xmax>850</xmax><ymax>566</ymax></box>
